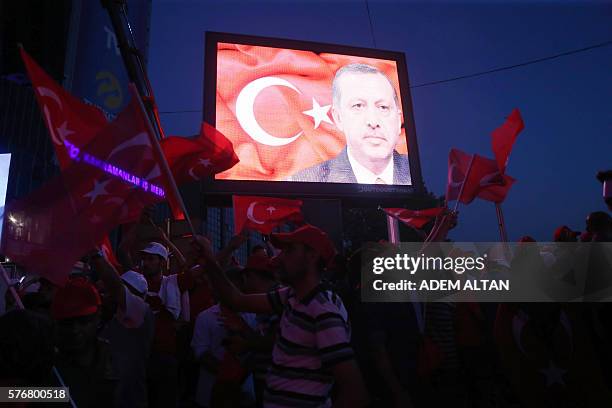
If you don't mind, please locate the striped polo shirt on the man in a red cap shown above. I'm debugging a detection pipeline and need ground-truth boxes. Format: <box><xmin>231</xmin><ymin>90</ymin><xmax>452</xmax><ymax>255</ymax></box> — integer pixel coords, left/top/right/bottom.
<box><xmin>264</xmin><ymin>284</ymin><xmax>354</xmax><ymax>408</ymax></box>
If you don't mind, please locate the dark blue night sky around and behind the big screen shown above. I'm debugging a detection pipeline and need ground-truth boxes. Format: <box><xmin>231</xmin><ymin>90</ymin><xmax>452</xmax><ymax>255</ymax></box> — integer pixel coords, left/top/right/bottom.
<box><xmin>149</xmin><ymin>0</ymin><xmax>612</xmax><ymax>241</ymax></box>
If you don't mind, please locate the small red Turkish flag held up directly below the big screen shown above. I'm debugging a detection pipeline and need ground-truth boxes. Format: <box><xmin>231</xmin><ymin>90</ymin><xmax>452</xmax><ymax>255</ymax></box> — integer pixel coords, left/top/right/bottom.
<box><xmin>232</xmin><ymin>196</ymin><xmax>304</xmax><ymax>234</ymax></box>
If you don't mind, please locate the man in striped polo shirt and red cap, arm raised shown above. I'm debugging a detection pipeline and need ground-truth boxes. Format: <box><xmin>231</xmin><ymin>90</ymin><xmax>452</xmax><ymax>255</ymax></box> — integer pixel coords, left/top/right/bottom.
<box><xmin>196</xmin><ymin>225</ymin><xmax>368</xmax><ymax>408</ymax></box>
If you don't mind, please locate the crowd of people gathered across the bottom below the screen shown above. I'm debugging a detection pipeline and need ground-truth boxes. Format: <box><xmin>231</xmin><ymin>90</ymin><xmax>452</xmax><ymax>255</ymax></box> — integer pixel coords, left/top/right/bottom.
<box><xmin>0</xmin><ymin>173</ymin><xmax>612</xmax><ymax>408</ymax></box>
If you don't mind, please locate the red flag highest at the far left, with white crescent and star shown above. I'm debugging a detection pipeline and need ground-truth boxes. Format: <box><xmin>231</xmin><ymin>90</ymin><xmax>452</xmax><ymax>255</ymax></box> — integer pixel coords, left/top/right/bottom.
<box><xmin>20</xmin><ymin>48</ymin><xmax>107</xmax><ymax>169</ymax></box>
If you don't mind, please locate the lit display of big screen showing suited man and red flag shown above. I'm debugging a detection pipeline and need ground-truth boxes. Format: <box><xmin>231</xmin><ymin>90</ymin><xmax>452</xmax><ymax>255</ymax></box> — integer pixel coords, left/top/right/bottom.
<box><xmin>214</xmin><ymin>43</ymin><xmax>412</xmax><ymax>185</ymax></box>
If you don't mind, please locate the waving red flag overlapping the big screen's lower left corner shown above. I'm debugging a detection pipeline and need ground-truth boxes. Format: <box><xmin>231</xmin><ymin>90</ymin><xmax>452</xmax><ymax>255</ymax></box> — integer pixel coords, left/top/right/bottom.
<box><xmin>160</xmin><ymin>122</ymin><xmax>239</xmax><ymax>184</ymax></box>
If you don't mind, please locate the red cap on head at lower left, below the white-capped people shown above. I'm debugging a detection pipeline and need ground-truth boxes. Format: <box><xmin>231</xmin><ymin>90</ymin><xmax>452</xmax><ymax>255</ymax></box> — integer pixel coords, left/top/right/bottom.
<box><xmin>51</xmin><ymin>278</ymin><xmax>102</xmax><ymax>320</ymax></box>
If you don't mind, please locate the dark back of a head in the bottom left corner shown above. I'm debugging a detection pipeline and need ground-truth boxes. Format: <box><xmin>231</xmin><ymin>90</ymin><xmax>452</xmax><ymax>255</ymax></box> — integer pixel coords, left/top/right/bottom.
<box><xmin>0</xmin><ymin>309</ymin><xmax>55</xmax><ymax>386</ymax></box>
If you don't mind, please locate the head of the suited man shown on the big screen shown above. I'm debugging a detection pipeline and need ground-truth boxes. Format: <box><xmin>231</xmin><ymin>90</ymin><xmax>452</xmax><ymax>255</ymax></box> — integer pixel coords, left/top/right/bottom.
<box><xmin>332</xmin><ymin>73</ymin><xmax>402</xmax><ymax>165</ymax></box>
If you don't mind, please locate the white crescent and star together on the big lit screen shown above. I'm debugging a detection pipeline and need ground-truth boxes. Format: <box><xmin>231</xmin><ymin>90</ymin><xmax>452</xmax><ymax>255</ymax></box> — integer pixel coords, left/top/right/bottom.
<box><xmin>236</xmin><ymin>76</ymin><xmax>333</xmax><ymax>147</ymax></box>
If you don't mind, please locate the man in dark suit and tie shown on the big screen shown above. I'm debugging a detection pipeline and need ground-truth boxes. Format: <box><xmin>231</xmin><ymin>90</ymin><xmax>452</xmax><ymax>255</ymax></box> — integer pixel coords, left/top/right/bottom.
<box><xmin>289</xmin><ymin>64</ymin><xmax>411</xmax><ymax>185</ymax></box>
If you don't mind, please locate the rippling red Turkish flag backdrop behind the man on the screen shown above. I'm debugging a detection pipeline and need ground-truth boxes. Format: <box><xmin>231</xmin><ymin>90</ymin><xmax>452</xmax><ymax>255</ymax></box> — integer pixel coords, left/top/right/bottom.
<box><xmin>216</xmin><ymin>43</ymin><xmax>407</xmax><ymax>181</ymax></box>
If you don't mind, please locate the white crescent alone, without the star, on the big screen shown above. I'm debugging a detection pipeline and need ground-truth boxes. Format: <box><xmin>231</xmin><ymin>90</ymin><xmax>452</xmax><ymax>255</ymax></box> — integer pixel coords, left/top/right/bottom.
<box><xmin>236</xmin><ymin>77</ymin><xmax>302</xmax><ymax>146</ymax></box>
